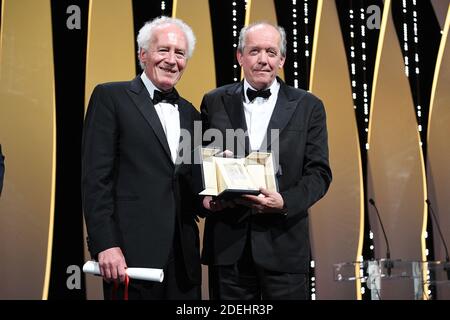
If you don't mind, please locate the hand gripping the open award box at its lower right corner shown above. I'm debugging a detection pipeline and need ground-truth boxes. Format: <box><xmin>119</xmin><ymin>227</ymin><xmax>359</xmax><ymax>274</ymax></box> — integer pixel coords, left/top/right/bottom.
<box><xmin>241</xmin><ymin>188</ymin><xmax>284</xmax><ymax>213</ymax></box>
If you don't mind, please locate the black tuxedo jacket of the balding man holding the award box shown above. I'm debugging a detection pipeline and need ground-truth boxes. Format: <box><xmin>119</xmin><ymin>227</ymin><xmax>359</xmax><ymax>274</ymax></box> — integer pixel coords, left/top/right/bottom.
<box><xmin>201</xmin><ymin>79</ymin><xmax>331</xmax><ymax>273</ymax></box>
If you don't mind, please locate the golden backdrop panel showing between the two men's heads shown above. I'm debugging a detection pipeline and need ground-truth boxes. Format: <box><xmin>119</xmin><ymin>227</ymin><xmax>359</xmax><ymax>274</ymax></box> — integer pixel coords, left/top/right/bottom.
<box><xmin>173</xmin><ymin>0</ymin><xmax>216</xmax><ymax>109</ymax></box>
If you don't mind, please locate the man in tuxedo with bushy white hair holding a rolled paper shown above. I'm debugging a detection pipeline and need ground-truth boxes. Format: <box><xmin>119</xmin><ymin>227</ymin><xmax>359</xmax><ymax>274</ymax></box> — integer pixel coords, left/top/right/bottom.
<box><xmin>82</xmin><ymin>17</ymin><xmax>201</xmax><ymax>300</ymax></box>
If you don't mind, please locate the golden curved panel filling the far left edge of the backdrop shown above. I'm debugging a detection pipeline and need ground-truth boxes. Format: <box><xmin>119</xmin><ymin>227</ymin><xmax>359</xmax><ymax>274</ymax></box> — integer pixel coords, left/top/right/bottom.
<box><xmin>0</xmin><ymin>0</ymin><xmax>56</xmax><ymax>299</ymax></box>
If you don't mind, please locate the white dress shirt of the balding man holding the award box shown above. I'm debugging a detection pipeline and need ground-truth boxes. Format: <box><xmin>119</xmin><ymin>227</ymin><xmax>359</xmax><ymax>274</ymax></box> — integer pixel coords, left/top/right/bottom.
<box><xmin>244</xmin><ymin>79</ymin><xmax>280</xmax><ymax>150</ymax></box>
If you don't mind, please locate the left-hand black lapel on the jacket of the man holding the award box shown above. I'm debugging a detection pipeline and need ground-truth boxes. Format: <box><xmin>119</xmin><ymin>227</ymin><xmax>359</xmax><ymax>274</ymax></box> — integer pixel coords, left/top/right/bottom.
<box><xmin>223</xmin><ymin>81</ymin><xmax>250</xmax><ymax>154</ymax></box>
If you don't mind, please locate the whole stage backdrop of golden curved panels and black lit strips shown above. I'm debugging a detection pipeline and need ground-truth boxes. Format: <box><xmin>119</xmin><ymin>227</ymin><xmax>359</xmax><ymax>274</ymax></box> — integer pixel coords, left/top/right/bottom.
<box><xmin>0</xmin><ymin>0</ymin><xmax>450</xmax><ymax>299</ymax></box>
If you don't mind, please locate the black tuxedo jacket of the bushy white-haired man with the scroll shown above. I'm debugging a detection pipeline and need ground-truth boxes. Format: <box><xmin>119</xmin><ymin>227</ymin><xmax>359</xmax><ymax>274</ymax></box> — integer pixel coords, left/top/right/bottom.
<box><xmin>82</xmin><ymin>77</ymin><xmax>201</xmax><ymax>283</ymax></box>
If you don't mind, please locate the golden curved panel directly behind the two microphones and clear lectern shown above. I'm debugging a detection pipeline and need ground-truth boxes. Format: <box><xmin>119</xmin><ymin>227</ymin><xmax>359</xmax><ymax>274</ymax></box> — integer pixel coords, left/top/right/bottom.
<box><xmin>368</xmin><ymin>0</ymin><xmax>427</xmax><ymax>299</ymax></box>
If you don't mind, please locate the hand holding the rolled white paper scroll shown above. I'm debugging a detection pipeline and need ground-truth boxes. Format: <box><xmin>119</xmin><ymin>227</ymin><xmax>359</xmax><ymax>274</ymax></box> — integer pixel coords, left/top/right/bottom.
<box><xmin>98</xmin><ymin>247</ymin><xmax>127</xmax><ymax>282</ymax></box>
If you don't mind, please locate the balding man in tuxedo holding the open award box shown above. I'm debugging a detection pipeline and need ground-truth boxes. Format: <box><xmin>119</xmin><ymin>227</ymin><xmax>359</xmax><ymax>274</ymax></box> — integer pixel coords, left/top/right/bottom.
<box><xmin>201</xmin><ymin>23</ymin><xmax>332</xmax><ymax>300</ymax></box>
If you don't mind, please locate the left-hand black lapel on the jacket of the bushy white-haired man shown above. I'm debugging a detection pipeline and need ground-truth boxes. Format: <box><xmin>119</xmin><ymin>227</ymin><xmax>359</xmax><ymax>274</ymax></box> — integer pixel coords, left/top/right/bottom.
<box><xmin>127</xmin><ymin>76</ymin><xmax>173</xmax><ymax>164</ymax></box>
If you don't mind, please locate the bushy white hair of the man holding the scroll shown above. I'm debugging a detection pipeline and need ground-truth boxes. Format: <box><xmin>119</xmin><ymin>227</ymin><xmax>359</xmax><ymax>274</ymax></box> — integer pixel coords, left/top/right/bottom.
<box><xmin>137</xmin><ymin>16</ymin><xmax>196</xmax><ymax>70</ymax></box>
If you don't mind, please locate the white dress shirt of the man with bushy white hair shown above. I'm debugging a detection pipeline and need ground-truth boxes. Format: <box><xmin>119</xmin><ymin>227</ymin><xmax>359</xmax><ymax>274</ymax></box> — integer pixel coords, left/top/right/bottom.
<box><xmin>141</xmin><ymin>72</ymin><xmax>180</xmax><ymax>163</ymax></box>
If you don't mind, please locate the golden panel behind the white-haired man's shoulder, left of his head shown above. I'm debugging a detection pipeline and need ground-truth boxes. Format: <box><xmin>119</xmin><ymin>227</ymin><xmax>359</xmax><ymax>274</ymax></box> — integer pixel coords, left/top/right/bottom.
<box><xmin>84</xmin><ymin>0</ymin><xmax>137</xmax><ymax>299</ymax></box>
